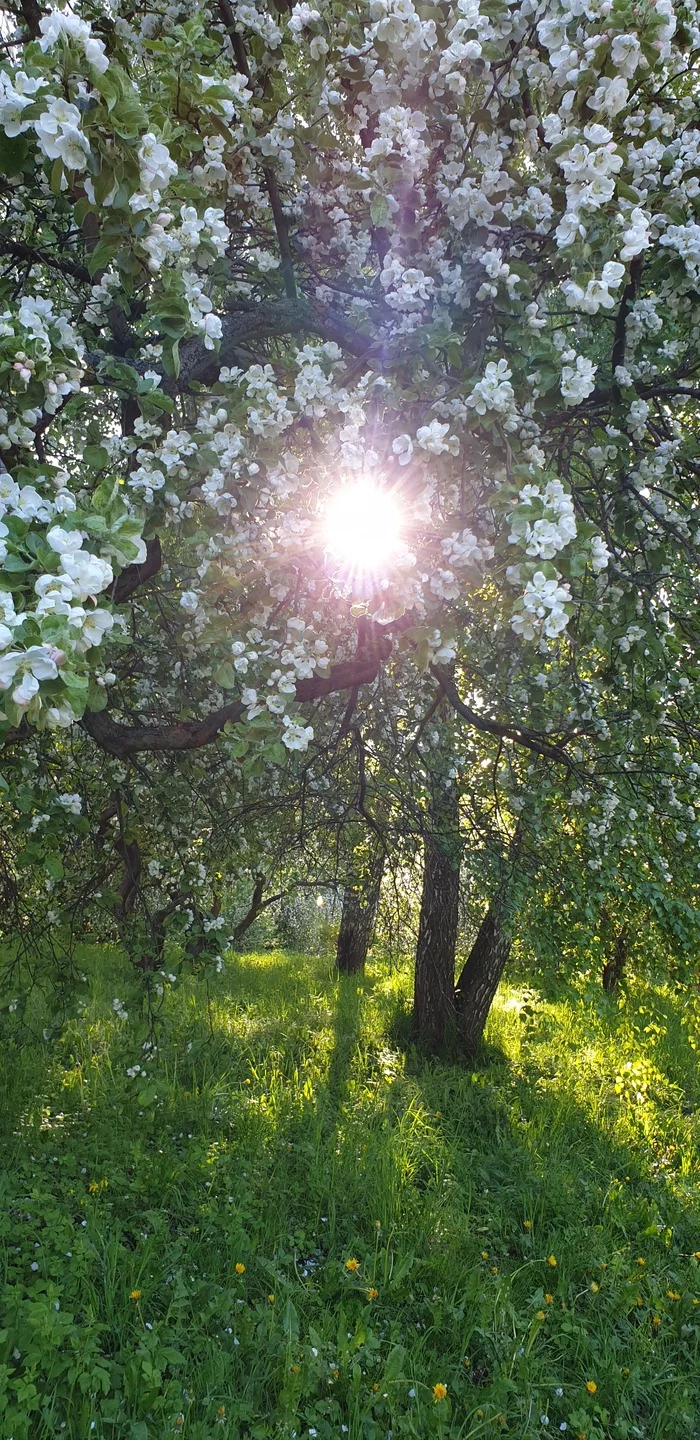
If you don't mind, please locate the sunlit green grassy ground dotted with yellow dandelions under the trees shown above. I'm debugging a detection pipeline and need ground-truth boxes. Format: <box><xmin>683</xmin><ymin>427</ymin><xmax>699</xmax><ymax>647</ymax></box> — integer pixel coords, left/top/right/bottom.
<box><xmin>0</xmin><ymin>952</ymin><xmax>700</xmax><ymax>1440</ymax></box>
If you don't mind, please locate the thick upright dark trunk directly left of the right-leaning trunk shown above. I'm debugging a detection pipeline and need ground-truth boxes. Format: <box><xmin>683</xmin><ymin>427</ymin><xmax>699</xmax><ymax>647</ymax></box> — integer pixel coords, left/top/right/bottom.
<box><xmin>413</xmin><ymin>785</ymin><xmax>459</xmax><ymax>1053</ymax></box>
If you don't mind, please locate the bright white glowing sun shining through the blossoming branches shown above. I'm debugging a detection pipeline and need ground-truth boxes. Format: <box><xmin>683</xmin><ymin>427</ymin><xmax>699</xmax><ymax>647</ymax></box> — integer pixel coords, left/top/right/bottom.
<box><xmin>324</xmin><ymin>480</ymin><xmax>403</xmax><ymax>576</ymax></box>
